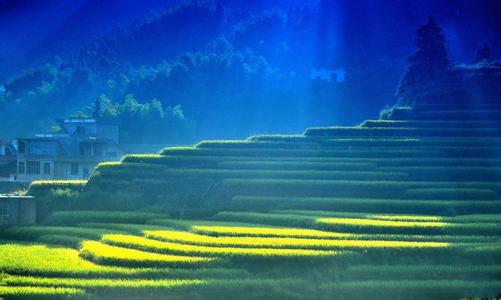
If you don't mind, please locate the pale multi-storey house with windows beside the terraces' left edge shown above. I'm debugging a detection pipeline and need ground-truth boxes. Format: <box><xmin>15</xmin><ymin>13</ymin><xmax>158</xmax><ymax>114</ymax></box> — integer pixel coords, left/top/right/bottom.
<box><xmin>13</xmin><ymin>118</ymin><xmax>122</xmax><ymax>182</ymax></box>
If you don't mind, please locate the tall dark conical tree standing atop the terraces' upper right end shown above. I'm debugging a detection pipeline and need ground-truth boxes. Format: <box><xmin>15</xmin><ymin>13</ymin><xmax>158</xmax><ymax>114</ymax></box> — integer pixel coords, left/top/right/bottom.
<box><xmin>397</xmin><ymin>17</ymin><xmax>451</xmax><ymax>104</ymax></box>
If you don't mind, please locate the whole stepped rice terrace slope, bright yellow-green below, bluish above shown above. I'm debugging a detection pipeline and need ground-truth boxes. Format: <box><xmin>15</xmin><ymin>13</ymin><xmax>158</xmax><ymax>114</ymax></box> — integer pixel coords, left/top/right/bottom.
<box><xmin>0</xmin><ymin>108</ymin><xmax>501</xmax><ymax>299</ymax></box>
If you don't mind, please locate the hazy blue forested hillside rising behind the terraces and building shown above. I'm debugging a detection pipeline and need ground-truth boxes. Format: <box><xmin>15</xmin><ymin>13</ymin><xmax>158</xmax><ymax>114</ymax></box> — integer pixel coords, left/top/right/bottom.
<box><xmin>0</xmin><ymin>0</ymin><xmax>496</xmax><ymax>144</ymax></box>
